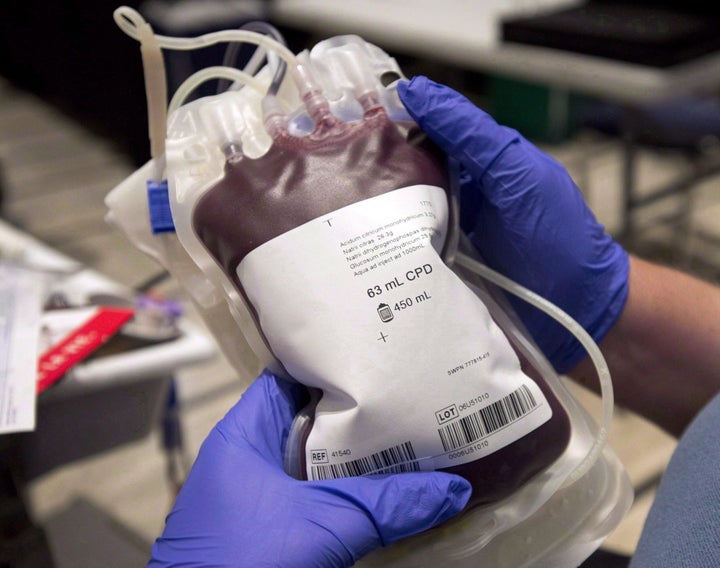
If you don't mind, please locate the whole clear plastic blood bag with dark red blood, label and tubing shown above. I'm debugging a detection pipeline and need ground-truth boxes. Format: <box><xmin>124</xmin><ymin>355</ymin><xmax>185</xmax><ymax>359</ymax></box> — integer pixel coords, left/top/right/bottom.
<box><xmin>107</xmin><ymin>8</ymin><xmax>631</xmax><ymax>566</ymax></box>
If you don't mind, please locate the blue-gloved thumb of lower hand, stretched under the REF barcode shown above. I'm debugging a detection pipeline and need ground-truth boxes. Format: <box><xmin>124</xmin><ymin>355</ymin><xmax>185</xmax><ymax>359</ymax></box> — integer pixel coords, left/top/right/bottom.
<box><xmin>310</xmin><ymin>472</ymin><xmax>472</xmax><ymax>557</ymax></box>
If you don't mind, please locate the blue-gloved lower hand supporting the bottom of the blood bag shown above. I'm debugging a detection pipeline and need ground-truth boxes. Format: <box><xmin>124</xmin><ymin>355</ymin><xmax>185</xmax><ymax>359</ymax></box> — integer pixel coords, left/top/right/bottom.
<box><xmin>149</xmin><ymin>371</ymin><xmax>471</xmax><ymax>568</ymax></box>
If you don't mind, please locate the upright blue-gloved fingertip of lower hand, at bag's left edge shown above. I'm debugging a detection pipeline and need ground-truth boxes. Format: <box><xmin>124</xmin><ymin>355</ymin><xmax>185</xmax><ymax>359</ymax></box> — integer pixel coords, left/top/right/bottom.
<box><xmin>216</xmin><ymin>370</ymin><xmax>307</xmax><ymax>464</ymax></box>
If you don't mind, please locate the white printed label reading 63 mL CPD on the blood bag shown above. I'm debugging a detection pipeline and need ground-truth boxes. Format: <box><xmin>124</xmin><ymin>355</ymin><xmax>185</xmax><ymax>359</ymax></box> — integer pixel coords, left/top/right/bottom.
<box><xmin>237</xmin><ymin>185</ymin><xmax>552</xmax><ymax>479</ymax></box>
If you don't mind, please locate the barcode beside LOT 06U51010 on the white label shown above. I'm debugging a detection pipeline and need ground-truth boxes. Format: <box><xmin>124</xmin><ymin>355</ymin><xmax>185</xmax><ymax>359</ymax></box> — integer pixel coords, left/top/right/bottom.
<box><xmin>438</xmin><ymin>385</ymin><xmax>538</xmax><ymax>452</ymax></box>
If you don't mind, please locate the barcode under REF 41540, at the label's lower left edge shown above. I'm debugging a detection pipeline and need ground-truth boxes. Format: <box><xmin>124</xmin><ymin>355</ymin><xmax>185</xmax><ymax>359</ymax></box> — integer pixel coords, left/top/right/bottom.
<box><xmin>310</xmin><ymin>442</ymin><xmax>420</xmax><ymax>480</ymax></box>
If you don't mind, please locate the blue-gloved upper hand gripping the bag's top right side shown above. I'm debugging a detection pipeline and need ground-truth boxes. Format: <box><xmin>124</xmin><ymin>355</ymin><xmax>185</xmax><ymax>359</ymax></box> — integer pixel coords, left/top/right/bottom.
<box><xmin>398</xmin><ymin>77</ymin><xmax>629</xmax><ymax>373</ymax></box>
